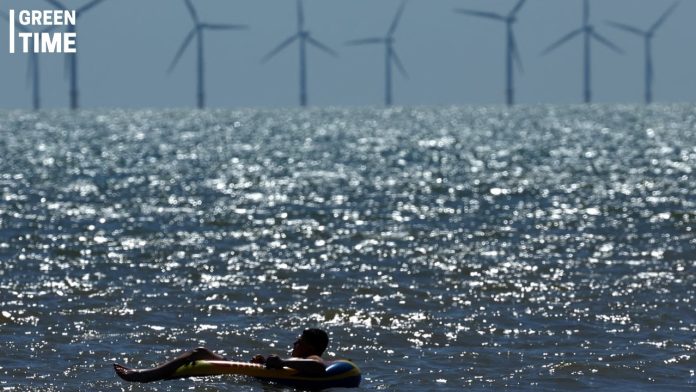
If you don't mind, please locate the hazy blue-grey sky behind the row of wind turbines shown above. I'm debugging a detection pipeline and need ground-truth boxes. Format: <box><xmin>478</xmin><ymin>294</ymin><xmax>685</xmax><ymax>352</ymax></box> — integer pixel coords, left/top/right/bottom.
<box><xmin>0</xmin><ymin>0</ymin><xmax>696</xmax><ymax>108</ymax></box>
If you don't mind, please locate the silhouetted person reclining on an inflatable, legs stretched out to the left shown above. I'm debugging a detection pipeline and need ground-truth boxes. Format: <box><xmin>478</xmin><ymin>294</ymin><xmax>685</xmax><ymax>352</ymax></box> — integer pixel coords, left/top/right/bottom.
<box><xmin>114</xmin><ymin>328</ymin><xmax>329</xmax><ymax>382</ymax></box>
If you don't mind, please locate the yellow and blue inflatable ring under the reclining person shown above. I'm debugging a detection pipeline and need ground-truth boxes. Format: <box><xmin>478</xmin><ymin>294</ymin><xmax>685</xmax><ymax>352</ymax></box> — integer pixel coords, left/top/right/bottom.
<box><xmin>172</xmin><ymin>360</ymin><xmax>362</xmax><ymax>390</ymax></box>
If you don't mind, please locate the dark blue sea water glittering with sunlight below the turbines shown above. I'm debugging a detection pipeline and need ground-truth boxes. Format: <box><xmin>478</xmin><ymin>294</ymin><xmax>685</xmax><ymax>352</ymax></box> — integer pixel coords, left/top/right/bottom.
<box><xmin>0</xmin><ymin>105</ymin><xmax>696</xmax><ymax>391</ymax></box>
